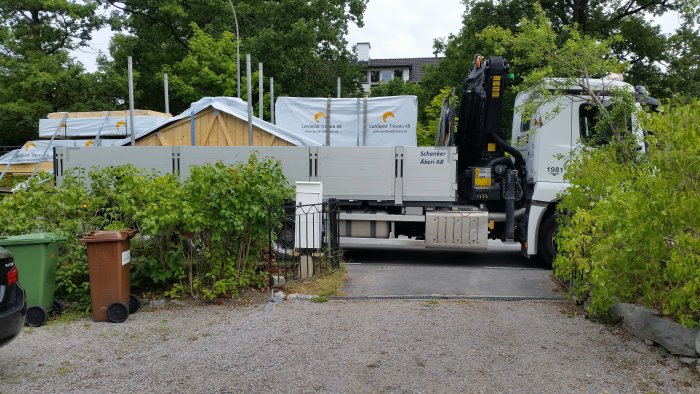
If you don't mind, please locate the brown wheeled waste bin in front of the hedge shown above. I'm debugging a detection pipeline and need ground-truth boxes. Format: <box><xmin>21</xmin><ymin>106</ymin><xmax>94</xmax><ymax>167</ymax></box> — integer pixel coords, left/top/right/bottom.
<box><xmin>80</xmin><ymin>230</ymin><xmax>138</xmax><ymax>323</ymax></box>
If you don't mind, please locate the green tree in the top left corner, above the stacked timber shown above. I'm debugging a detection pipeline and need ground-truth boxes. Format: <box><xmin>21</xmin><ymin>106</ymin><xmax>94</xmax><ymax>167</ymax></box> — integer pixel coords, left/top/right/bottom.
<box><xmin>0</xmin><ymin>0</ymin><xmax>113</xmax><ymax>145</ymax></box>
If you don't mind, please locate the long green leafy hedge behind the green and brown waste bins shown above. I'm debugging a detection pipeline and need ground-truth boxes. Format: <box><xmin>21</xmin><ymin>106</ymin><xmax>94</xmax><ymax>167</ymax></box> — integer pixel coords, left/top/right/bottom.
<box><xmin>0</xmin><ymin>156</ymin><xmax>292</xmax><ymax>309</ymax></box>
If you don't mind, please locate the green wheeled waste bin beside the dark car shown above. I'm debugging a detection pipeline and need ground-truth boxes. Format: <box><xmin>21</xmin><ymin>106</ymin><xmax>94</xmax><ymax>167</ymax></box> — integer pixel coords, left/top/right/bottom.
<box><xmin>0</xmin><ymin>233</ymin><xmax>65</xmax><ymax>327</ymax></box>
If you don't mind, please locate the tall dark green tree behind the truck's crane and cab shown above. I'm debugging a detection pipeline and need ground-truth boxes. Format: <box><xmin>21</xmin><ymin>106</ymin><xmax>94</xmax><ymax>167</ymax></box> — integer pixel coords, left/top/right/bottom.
<box><xmin>424</xmin><ymin>0</ymin><xmax>697</xmax><ymax>101</ymax></box>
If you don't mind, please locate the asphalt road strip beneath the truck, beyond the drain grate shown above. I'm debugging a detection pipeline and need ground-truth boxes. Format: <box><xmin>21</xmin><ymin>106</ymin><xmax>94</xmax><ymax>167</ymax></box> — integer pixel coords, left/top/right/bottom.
<box><xmin>343</xmin><ymin>241</ymin><xmax>560</xmax><ymax>297</ymax></box>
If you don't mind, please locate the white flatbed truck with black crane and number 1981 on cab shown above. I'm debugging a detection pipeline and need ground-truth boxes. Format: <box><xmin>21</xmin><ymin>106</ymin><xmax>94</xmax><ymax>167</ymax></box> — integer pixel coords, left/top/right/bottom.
<box><xmin>54</xmin><ymin>57</ymin><xmax>652</xmax><ymax>264</ymax></box>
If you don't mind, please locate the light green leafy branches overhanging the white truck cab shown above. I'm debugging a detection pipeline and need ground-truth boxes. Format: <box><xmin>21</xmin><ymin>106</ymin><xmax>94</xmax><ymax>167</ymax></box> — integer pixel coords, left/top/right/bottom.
<box><xmin>478</xmin><ymin>4</ymin><xmax>635</xmax><ymax>140</ymax></box>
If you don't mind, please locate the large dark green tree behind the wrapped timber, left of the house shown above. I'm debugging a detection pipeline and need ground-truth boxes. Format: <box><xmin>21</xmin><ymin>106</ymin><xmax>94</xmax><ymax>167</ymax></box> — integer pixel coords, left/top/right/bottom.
<box><xmin>103</xmin><ymin>0</ymin><xmax>366</xmax><ymax>112</ymax></box>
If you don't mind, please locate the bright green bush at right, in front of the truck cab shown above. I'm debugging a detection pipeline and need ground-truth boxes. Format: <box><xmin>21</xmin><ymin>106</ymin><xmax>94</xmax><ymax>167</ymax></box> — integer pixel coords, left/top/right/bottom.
<box><xmin>554</xmin><ymin>101</ymin><xmax>700</xmax><ymax>327</ymax></box>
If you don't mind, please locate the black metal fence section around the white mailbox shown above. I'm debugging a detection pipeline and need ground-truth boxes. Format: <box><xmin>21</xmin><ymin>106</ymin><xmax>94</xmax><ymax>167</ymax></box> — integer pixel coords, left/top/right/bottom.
<box><xmin>268</xmin><ymin>199</ymin><xmax>342</xmax><ymax>287</ymax></box>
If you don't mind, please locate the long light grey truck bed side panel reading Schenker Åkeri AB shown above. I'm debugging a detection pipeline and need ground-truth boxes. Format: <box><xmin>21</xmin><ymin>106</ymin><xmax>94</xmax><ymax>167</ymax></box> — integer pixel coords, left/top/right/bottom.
<box><xmin>56</xmin><ymin>146</ymin><xmax>457</xmax><ymax>205</ymax></box>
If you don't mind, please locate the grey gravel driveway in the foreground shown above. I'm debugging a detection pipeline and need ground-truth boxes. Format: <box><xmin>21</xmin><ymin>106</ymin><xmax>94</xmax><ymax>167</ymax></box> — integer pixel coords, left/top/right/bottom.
<box><xmin>0</xmin><ymin>300</ymin><xmax>700</xmax><ymax>393</ymax></box>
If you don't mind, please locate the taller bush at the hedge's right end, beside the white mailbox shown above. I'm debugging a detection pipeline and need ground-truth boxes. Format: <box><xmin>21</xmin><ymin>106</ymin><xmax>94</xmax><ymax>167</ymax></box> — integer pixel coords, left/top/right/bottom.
<box><xmin>181</xmin><ymin>156</ymin><xmax>292</xmax><ymax>299</ymax></box>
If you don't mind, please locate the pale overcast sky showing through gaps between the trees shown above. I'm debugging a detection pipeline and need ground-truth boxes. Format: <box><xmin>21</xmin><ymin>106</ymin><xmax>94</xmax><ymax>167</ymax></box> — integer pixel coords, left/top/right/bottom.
<box><xmin>73</xmin><ymin>0</ymin><xmax>680</xmax><ymax>71</ymax></box>
